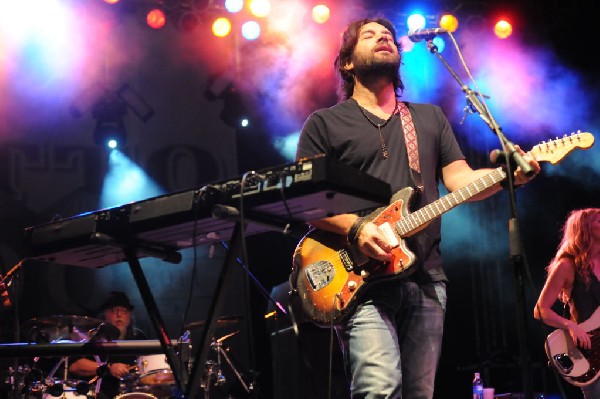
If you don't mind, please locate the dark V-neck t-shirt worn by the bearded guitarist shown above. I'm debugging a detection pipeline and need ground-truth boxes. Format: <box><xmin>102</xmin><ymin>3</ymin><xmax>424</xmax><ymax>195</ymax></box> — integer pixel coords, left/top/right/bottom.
<box><xmin>296</xmin><ymin>99</ymin><xmax>465</xmax><ymax>281</ymax></box>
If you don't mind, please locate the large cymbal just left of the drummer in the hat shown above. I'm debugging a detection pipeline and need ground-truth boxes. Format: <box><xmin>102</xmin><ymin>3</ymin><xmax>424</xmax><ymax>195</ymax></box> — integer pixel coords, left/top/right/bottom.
<box><xmin>21</xmin><ymin>315</ymin><xmax>102</xmax><ymax>341</ymax></box>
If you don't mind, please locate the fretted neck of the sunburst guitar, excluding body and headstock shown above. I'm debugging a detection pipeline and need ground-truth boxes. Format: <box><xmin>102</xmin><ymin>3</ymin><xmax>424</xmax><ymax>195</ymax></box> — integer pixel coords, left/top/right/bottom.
<box><xmin>396</xmin><ymin>167</ymin><xmax>506</xmax><ymax>237</ymax></box>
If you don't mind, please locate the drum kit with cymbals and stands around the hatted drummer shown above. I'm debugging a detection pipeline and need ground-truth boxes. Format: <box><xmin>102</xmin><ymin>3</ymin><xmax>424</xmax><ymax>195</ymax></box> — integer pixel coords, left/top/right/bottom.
<box><xmin>0</xmin><ymin>315</ymin><xmax>246</xmax><ymax>399</ymax></box>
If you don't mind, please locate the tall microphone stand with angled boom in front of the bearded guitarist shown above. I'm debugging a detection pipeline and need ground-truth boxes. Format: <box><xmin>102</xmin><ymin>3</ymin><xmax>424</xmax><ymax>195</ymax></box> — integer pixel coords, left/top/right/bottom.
<box><xmin>425</xmin><ymin>38</ymin><xmax>534</xmax><ymax>399</ymax></box>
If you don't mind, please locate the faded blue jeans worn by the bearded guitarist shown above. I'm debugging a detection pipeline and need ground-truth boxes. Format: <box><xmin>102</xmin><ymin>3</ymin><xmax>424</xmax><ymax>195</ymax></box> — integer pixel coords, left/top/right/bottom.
<box><xmin>336</xmin><ymin>280</ymin><xmax>446</xmax><ymax>399</ymax></box>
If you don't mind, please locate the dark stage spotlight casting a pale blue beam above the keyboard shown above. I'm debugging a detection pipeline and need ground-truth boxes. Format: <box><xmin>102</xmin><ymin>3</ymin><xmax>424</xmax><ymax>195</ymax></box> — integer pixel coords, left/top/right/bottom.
<box><xmin>92</xmin><ymin>95</ymin><xmax>127</xmax><ymax>148</ymax></box>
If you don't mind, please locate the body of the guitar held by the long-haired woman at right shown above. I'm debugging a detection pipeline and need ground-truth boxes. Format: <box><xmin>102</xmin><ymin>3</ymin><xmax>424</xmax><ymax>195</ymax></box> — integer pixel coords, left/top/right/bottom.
<box><xmin>545</xmin><ymin>308</ymin><xmax>600</xmax><ymax>387</ymax></box>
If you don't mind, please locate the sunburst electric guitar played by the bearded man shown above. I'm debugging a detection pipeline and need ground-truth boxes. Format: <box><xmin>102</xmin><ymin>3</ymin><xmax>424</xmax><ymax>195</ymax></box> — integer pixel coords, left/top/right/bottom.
<box><xmin>290</xmin><ymin>132</ymin><xmax>594</xmax><ymax>325</ymax></box>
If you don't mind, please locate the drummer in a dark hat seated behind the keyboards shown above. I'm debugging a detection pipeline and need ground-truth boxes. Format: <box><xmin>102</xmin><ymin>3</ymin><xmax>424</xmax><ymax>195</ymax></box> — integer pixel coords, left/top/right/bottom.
<box><xmin>69</xmin><ymin>291</ymin><xmax>147</xmax><ymax>399</ymax></box>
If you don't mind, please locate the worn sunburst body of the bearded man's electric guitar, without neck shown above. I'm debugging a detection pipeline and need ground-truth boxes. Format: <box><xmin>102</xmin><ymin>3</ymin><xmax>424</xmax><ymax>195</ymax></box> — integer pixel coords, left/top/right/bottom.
<box><xmin>292</xmin><ymin>187</ymin><xmax>415</xmax><ymax>326</ymax></box>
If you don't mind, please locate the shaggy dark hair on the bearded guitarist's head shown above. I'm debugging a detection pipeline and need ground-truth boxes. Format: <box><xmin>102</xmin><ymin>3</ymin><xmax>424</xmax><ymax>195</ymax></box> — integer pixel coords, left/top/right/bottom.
<box><xmin>334</xmin><ymin>17</ymin><xmax>404</xmax><ymax>100</ymax></box>
